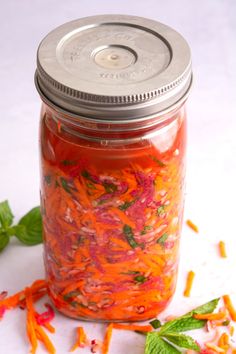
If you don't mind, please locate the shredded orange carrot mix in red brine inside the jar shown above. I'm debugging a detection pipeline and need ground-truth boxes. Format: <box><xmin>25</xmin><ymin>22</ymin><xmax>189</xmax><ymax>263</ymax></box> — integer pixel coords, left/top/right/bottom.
<box><xmin>42</xmin><ymin>112</ymin><xmax>185</xmax><ymax>322</ymax></box>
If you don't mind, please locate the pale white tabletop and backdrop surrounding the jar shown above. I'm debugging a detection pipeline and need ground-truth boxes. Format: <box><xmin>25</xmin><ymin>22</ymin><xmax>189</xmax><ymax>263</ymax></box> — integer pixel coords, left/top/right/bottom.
<box><xmin>0</xmin><ymin>0</ymin><xmax>236</xmax><ymax>354</ymax></box>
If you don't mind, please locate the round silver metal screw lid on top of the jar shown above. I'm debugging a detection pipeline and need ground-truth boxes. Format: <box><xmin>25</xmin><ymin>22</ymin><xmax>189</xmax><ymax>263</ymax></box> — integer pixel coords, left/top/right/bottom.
<box><xmin>35</xmin><ymin>15</ymin><xmax>192</xmax><ymax>121</ymax></box>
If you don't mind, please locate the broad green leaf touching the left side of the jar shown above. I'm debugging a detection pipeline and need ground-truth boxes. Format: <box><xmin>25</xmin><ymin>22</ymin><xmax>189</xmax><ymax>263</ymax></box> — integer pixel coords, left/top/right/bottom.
<box><xmin>14</xmin><ymin>207</ymin><xmax>42</xmax><ymax>246</ymax></box>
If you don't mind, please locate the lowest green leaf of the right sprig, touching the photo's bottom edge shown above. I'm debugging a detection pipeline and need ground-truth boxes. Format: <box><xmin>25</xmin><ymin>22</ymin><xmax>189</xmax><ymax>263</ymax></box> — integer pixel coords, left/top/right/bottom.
<box><xmin>145</xmin><ymin>332</ymin><xmax>181</xmax><ymax>354</ymax></box>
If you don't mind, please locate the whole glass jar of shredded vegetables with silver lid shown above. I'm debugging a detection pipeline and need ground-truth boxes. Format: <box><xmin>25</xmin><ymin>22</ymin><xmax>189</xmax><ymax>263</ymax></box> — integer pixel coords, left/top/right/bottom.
<box><xmin>35</xmin><ymin>15</ymin><xmax>192</xmax><ymax>321</ymax></box>
